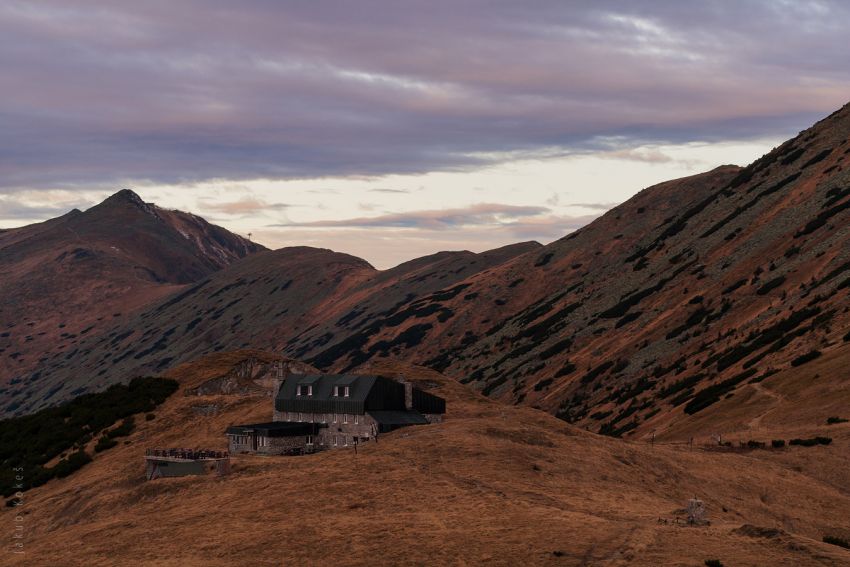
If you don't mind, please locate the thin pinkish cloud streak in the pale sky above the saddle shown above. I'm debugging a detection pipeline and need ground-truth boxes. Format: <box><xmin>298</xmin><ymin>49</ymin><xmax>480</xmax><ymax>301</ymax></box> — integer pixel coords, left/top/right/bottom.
<box><xmin>270</xmin><ymin>203</ymin><xmax>550</xmax><ymax>230</ymax></box>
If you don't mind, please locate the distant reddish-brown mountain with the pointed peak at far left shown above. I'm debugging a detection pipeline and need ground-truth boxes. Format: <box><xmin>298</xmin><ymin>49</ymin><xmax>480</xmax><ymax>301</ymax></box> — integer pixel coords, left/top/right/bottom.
<box><xmin>0</xmin><ymin>190</ymin><xmax>261</xmax><ymax>390</ymax></box>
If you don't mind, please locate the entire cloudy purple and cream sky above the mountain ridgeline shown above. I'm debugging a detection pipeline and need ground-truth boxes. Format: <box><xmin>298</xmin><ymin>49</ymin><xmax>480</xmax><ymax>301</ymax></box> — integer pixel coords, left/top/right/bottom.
<box><xmin>0</xmin><ymin>0</ymin><xmax>850</xmax><ymax>268</ymax></box>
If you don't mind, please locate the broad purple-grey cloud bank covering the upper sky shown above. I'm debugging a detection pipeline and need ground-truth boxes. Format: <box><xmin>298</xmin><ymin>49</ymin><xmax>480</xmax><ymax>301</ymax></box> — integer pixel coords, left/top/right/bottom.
<box><xmin>0</xmin><ymin>0</ymin><xmax>850</xmax><ymax>191</ymax></box>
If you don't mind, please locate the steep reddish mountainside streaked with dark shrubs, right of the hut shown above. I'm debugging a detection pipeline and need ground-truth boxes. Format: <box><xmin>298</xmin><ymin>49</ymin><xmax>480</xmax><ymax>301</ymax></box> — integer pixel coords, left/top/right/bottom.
<box><xmin>290</xmin><ymin>101</ymin><xmax>850</xmax><ymax>444</ymax></box>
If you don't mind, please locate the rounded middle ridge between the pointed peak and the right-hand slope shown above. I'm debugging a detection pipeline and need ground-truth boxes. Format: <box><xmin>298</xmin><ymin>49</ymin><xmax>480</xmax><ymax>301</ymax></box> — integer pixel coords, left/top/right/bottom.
<box><xmin>5</xmin><ymin>243</ymin><xmax>540</xmax><ymax>413</ymax></box>
